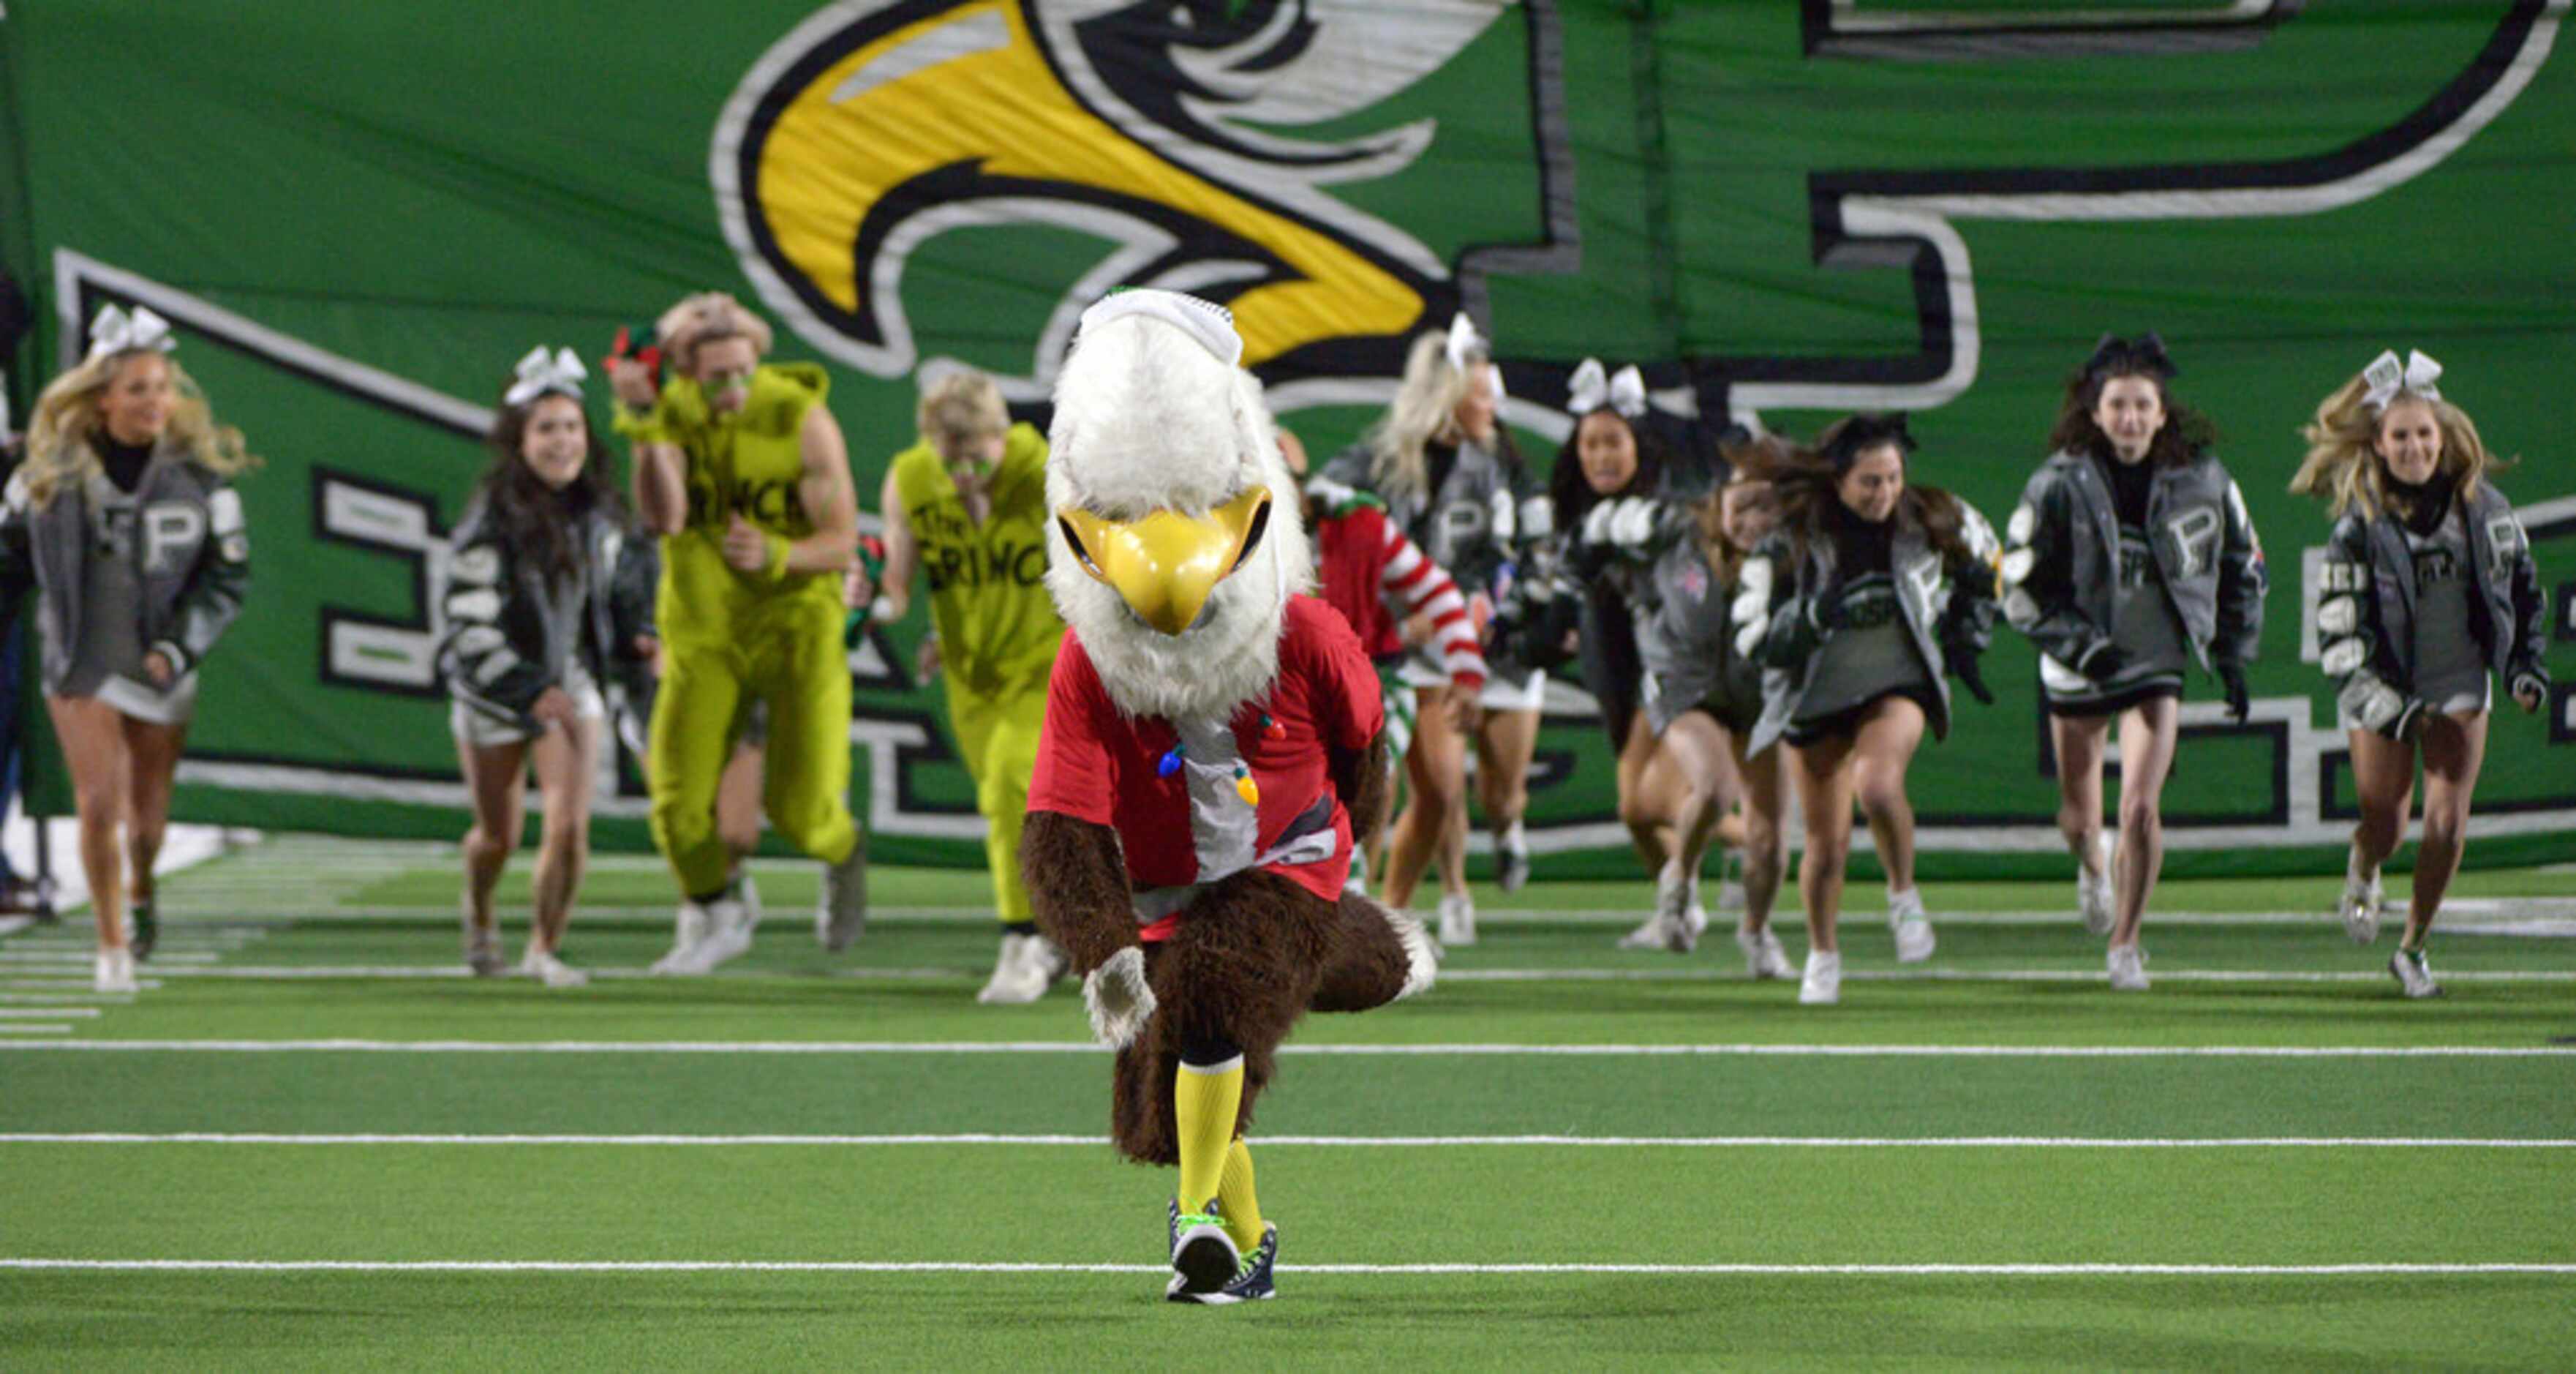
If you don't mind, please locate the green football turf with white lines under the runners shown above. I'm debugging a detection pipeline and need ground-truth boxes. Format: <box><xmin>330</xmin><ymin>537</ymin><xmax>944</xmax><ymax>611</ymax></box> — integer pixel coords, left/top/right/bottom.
<box><xmin>0</xmin><ymin>841</ymin><xmax>2576</xmax><ymax>1369</ymax></box>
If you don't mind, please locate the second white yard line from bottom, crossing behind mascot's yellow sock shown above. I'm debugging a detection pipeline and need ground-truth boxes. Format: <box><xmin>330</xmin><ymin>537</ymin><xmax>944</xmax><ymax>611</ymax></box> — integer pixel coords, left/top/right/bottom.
<box><xmin>0</xmin><ymin>1132</ymin><xmax>2576</xmax><ymax>1149</ymax></box>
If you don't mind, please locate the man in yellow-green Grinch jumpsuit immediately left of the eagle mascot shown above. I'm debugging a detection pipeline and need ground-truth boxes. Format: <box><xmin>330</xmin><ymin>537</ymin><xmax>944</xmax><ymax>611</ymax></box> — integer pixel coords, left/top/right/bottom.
<box><xmin>850</xmin><ymin>371</ymin><xmax>1066</xmax><ymax>1003</ymax></box>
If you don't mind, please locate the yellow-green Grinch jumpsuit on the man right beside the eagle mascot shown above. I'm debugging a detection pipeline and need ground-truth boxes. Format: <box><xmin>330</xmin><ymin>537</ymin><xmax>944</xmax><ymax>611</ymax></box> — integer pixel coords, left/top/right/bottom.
<box><xmin>894</xmin><ymin>425</ymin><xmax>1064</xmax><ymax>926</ymax></box>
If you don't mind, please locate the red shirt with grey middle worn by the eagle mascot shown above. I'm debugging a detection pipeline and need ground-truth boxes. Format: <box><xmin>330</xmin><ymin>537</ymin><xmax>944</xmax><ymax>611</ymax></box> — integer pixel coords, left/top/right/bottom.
<box><xmin>1028</xmin><ymin>596</ymin><xmax>1386</xmax><ymax>902</ymax></box>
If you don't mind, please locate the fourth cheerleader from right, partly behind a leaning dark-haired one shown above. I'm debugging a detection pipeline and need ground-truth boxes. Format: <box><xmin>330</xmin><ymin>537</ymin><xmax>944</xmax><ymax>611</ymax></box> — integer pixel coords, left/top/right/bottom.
<box><xmin>1610</xmin><ymin>441</ymin><xmax>1793</xmax><ymax>980</ymax></box>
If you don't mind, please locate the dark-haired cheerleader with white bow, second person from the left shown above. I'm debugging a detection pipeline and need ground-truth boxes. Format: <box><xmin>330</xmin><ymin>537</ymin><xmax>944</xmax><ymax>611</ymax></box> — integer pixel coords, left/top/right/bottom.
<box><xmin>438</xmin><ymin>348</ymin><xmax>626</xmax><ymax>987</ymax></box>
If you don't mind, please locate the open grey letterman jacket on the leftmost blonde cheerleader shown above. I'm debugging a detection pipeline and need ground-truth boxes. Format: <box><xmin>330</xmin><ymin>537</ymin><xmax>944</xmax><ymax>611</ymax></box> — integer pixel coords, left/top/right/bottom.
<box><xmin>0</xmin><ymin>441</ymin><xmax>250</xmax><ymax>691</ymax></box>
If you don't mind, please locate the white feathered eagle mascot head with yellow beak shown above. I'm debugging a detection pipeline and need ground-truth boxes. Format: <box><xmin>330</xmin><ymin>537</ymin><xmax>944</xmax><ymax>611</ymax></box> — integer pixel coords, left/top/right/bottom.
<box><xmin>1046</xmin><ymin>291</ymin><xmax>1314</xmax><ymax>719</ymax></box>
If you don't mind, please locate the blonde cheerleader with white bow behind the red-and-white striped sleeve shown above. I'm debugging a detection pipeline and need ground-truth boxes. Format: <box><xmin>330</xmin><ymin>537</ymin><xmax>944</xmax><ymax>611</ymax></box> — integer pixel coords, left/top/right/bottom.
<box><xmin>1324</xmin><ymin>315</ymin><xmax>1551</xmax><ymax>944</ymax></box>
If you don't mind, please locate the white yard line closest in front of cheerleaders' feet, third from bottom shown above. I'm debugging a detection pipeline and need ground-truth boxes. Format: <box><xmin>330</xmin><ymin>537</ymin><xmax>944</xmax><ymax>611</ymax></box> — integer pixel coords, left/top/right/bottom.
<box><xmin>23</xmin><ymin>1039</ymin><xmax>2576</xmax><ymax>1059</ymax></box>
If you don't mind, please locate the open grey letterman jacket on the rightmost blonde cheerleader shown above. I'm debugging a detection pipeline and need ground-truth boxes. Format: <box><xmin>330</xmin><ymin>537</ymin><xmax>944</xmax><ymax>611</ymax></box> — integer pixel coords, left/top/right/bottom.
<box><xmin>2316</xmin><ymin>482</ymin><xmax>2550</xmax><ymax>740</ymax></box>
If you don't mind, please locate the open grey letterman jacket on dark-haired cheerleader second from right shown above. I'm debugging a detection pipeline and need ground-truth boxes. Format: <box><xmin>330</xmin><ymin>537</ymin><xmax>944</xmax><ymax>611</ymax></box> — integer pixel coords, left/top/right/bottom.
<box><xmin>2002</xmin><ymin>454</ymin><xmax>2264</xmax><ymax>691</ymax></box>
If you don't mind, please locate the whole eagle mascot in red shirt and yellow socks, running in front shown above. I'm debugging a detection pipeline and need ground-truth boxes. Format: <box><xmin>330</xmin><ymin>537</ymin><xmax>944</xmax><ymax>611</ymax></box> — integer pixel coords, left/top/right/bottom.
<box><xmin>1020</xmin><ymin>291</ymin><xmax>1435</xmax><ymax>1304</ymax></box>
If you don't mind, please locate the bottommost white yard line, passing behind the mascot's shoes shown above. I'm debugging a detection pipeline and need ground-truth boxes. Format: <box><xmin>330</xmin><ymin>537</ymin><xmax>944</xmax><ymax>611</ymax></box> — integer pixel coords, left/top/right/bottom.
<box><xmin>0</xmin><ymin>1258</ymin><xmax>2576</xmax><ymax>1279</ymax></box>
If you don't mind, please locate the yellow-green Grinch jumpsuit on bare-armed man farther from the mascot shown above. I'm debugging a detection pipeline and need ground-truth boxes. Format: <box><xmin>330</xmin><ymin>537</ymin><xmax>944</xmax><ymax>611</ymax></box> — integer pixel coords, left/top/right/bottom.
<box><xmin>618</xmin><ymin>364</ymin><xmax>860</xmax><ymax>897</ymax></box>
